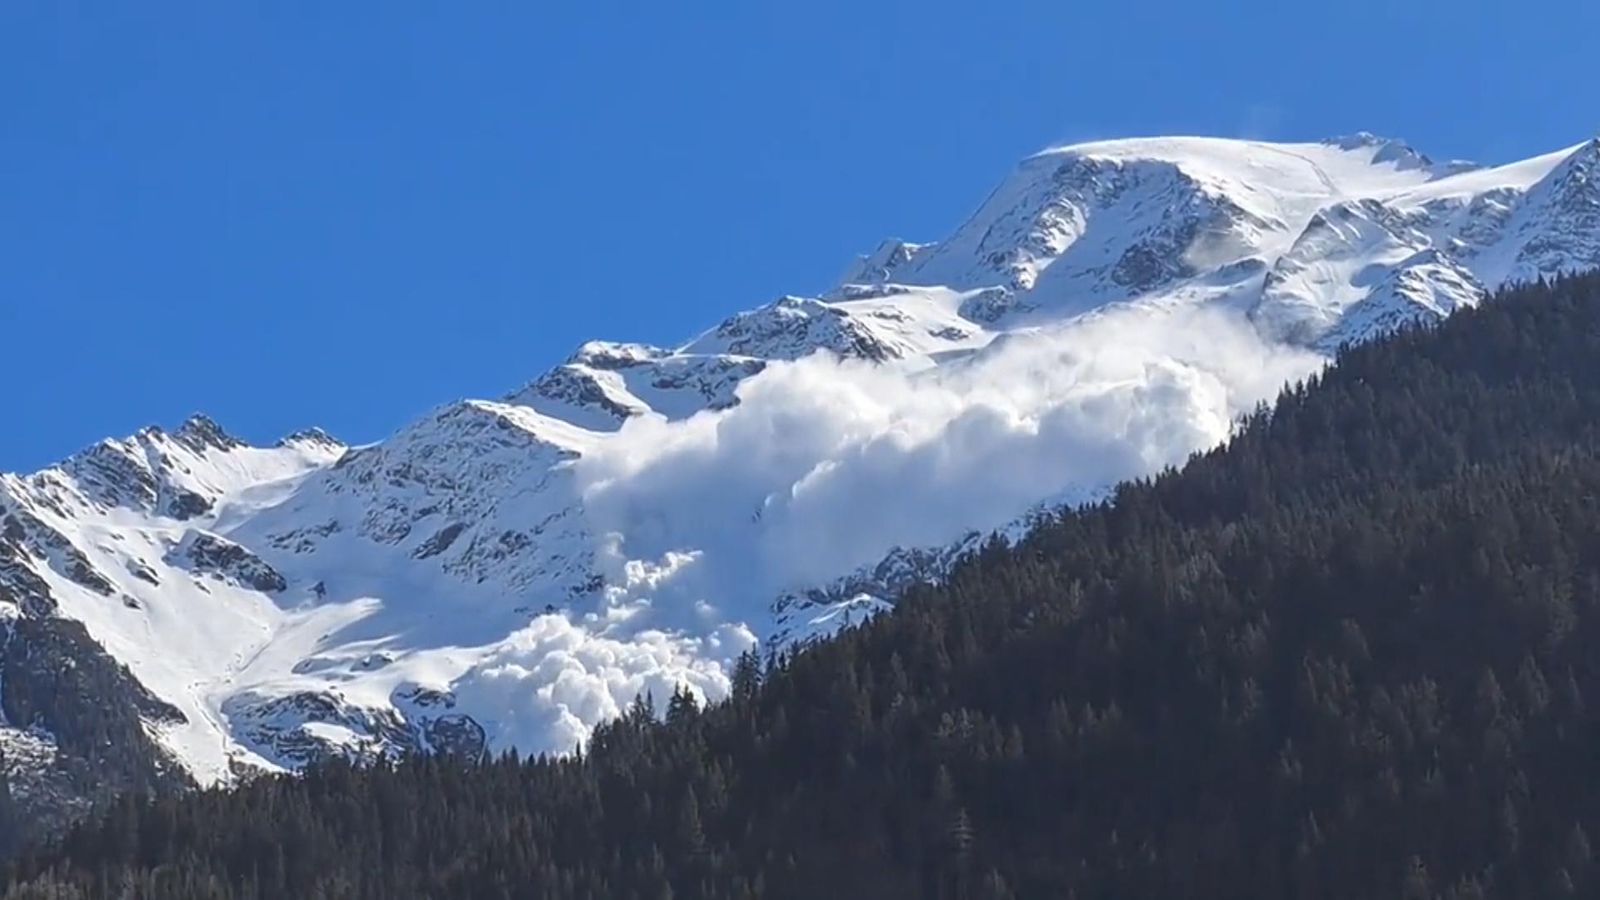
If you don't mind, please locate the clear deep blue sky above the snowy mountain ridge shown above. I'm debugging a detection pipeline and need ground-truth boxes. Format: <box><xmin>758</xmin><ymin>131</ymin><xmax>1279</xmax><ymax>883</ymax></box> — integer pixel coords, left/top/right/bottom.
<box><xmin>0</xmin><ymin>0</ymin><xmax>1600</xmax><ymax>471</ymax></box>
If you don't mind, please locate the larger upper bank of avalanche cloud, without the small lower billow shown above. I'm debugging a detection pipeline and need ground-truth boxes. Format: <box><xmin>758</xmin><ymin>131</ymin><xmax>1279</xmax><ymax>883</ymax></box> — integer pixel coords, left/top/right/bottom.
<box><xmin>578</xmin><ymin>307</ymin><xmax>1323</xmax><ymax>611</ymax></box>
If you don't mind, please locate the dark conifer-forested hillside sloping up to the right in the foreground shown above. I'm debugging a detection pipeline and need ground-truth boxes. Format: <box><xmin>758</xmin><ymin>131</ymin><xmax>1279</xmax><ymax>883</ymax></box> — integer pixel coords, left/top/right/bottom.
<box><xmin>6</xmin><ymin>277</ymin><xmax>1600</xmax><ymax>900</ymax></box>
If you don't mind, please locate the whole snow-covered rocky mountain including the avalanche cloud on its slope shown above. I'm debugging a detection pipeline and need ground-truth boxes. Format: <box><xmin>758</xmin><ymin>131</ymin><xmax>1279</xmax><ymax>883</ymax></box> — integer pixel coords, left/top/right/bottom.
<box><xmin>0</xmin><ymin>128</ymin><xmax>1600</xmax><ymax>807</ymax></box>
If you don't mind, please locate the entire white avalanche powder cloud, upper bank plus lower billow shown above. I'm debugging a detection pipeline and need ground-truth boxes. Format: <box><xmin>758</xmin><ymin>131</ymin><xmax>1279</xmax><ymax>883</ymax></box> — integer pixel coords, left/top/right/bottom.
<box><xmin>435</xmin><ymin>301</ymin><xmax>1323</xmax><ymax>749</ymax></box>
